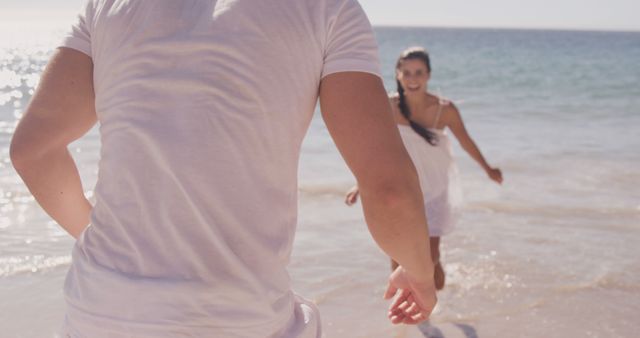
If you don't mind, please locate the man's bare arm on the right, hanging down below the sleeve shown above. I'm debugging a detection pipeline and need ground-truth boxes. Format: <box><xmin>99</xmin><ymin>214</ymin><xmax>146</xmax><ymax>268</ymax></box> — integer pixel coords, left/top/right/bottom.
<box><xmin>320</xmin><ymin>72</ymin><xmax>435</xmax><ymax>322</ymax></box>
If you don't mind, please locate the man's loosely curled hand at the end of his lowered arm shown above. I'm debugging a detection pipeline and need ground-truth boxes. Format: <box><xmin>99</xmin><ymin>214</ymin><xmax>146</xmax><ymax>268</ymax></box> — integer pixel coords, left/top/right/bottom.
<box><xmin>384</xmin><ymin>266</ymin><xmax>437</xmax><ymax>324</ymax></box>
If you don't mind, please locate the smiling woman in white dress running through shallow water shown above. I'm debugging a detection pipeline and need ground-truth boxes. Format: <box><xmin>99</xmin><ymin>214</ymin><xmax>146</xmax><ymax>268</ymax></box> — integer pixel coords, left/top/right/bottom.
<box><xmin>346</xmin><ymin>47</ymin><xmax>502</xmax><ymax>290</ymax></box>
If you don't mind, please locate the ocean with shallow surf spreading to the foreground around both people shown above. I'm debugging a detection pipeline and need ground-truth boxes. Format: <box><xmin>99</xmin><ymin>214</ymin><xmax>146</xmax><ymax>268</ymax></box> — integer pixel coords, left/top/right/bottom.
<box><xmin>0</xmin><ymin>23</ymin><xmax>640</xmax><ymax>338</ymax></box>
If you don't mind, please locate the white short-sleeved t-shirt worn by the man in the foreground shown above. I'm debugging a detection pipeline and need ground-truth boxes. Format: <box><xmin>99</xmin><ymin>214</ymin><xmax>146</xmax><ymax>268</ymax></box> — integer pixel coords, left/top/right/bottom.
<box><xmin>62</xmin><ymin>0</ymin><xmax>380</xmax><ymax>337</ymax></box>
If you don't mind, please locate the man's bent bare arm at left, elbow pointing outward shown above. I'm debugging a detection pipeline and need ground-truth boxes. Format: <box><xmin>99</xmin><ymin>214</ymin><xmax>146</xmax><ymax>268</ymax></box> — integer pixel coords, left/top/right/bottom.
<box><xmin>11</xmin><ymin>48</ymin><xmax>97</xmax><ymax>238</ymax></box>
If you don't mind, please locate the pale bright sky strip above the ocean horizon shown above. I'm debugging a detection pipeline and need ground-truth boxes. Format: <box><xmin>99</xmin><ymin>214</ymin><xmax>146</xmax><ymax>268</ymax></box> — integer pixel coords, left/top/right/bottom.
<box><xmin>0</xmin><ymin>0</ymin><xmax>640</xmax><ymax>31</ymax></box>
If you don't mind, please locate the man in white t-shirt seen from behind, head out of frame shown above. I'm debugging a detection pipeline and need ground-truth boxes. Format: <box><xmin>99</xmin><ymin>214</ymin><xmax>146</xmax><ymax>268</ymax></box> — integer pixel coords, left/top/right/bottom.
<box><xmin>11</xmin><ymin>0</ymin><xmax>435</xmax><ymax>337</ymax></box>
